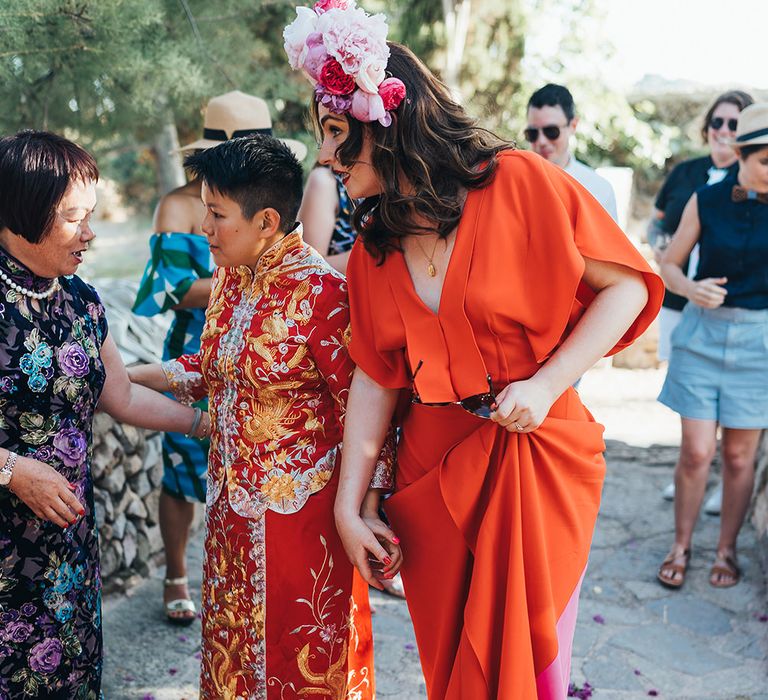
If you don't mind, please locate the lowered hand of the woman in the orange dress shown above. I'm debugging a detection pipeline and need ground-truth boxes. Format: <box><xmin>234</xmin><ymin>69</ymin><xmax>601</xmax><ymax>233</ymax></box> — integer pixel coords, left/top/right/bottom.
<box><xmin>336</xmin><ymin>512</ymin><xmax>402</xmax><ymax>590</ymax></box>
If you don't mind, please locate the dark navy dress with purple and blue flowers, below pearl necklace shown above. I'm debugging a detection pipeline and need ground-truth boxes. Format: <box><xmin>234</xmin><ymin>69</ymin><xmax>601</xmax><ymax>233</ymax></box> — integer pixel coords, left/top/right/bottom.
<box><xmin>0</xmin><ymin>248</ymin><xmax>107</xmax><ymax>700</ymax></box>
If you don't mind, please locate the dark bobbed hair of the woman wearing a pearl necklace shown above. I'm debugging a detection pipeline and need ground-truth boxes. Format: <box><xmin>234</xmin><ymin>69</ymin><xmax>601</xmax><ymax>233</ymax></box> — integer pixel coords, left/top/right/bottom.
<box><xmin>0</xmin><ymin>129</ymin><xmax>99</xmax><ymax>243</ymax></box>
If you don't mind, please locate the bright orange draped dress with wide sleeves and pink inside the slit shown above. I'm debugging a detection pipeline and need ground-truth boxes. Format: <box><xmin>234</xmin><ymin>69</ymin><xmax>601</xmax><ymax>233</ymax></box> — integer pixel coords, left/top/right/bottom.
<box><xmin>348</xmin><ymin>151</ymin><xmax>664</xmax><ymax>700</ymax></box>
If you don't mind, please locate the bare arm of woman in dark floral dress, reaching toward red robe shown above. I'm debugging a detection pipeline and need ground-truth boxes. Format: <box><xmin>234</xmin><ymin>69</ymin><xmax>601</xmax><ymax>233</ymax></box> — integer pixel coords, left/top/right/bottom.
<box><xmin>99</xmin><ymin>336</ymin><xmax>204</xmax><ymax>435</ymax></box>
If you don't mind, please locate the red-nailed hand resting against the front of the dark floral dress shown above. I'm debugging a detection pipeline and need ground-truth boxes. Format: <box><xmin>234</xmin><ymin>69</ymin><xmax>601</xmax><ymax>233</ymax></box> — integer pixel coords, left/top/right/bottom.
<box><xmin>8</xmin><ymin>456</ymin><xmax>85</xmax><ymax>528</ymax></box>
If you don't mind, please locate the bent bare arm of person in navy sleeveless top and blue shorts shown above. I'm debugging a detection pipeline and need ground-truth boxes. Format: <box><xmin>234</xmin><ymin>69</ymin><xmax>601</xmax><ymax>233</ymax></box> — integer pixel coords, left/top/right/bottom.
<box><xmin>661</xmin><ymin>194</ymin><xmax>728</xmax><ymax>309</ymax></box>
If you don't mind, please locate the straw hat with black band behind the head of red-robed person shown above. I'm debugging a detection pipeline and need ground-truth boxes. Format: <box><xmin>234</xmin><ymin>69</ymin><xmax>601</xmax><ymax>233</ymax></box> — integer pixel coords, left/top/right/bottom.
<box><xmin>179</xmin><ymin>90</ymin><xmax>307</xmax><ymax>160</ymax></box>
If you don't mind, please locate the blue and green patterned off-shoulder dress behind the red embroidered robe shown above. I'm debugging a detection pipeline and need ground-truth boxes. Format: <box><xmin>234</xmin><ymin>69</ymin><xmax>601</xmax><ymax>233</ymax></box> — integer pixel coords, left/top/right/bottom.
<box><xmin>133</xmin><ymin>232</ymin><xmax>214</xmax><ymax>503</ymax></box>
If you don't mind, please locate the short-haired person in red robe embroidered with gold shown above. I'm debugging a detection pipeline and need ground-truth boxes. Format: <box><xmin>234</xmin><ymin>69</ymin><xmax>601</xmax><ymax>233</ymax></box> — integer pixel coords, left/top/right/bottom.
<box><xmin>127</xmin><ymin>136</ymin><xmax>399</xmax><ymax>700</ymax></box>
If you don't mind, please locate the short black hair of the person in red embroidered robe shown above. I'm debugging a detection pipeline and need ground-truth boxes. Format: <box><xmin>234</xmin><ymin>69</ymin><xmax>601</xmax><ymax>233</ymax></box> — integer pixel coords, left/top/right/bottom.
<box><xmin>184</xmin><ymin>134</ymin><xmax>304</xmax><ymax>232</ymax></box>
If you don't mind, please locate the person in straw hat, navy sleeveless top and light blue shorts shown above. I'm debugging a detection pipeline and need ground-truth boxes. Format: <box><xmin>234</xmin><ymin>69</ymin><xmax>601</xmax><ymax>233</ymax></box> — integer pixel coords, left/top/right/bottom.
<box><xmin>658</xmin><ymin>104</ymin><xmax>768</xmax><ymax>588</ymax></box>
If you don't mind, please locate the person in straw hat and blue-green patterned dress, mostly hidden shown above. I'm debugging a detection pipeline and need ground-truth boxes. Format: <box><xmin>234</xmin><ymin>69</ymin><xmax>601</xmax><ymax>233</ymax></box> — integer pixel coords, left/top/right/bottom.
<box><xmin>133</xmin><ymin>90</ymin><xmax>307</xmax><ymax>625</ymax></box>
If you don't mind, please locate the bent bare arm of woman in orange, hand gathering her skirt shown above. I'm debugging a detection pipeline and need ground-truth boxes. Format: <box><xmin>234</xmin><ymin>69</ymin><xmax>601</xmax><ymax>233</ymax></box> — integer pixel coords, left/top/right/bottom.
<box><xmin>491</xmin><ymin>258</ymin><xmax>648</xmax><ymax>432</ymax></box>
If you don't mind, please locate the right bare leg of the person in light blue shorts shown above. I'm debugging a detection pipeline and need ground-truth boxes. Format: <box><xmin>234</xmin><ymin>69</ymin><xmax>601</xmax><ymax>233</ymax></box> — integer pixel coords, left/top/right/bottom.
<box><xmin>712</xmin><ymin>428</ymin><xmax>761</xmax><ymax>585</ymax></box>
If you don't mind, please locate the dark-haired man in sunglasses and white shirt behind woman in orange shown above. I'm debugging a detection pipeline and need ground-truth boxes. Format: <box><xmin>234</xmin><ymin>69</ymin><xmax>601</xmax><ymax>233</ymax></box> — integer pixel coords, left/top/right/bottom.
<box><xmin>524</xmin><ymin>83</ymin><xmax>618</xmax><ymax>221</ymax></box>
